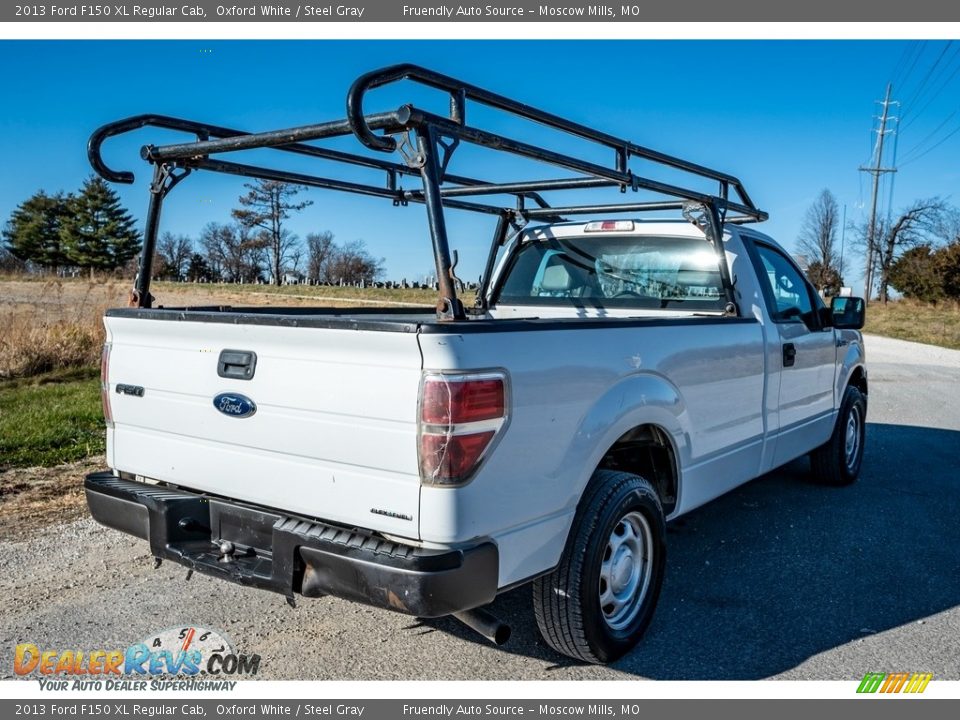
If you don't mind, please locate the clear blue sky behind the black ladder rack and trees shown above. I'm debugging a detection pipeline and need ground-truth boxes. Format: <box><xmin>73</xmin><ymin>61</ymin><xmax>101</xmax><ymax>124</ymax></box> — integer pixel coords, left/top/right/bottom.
<box><xmin>0</xmin><ymin>40</ymin><xmax>960</xmax><ymax>287</ymax></box>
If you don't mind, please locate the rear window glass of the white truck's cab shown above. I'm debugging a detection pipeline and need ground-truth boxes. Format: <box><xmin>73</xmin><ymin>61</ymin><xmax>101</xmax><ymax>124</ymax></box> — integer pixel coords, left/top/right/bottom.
<box><xmin>494</xmin><ymin>235</ymin><xmax>725</xmax><ymax>310</ymax></box>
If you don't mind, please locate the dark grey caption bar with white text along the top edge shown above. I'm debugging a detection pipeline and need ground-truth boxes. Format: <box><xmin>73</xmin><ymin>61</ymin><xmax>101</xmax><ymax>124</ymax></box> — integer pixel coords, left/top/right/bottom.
<box><xmin>7</xmin><ymin>0</ymin><xmax>960</xmax><ymax>23</ymax></box>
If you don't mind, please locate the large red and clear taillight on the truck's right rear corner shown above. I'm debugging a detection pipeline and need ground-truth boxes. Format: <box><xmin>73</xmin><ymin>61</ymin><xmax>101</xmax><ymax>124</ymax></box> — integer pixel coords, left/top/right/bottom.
<box><xmin>419</xmin><ymin>373</ymin><xmax>507</xmax><ymax>485</ymax></box>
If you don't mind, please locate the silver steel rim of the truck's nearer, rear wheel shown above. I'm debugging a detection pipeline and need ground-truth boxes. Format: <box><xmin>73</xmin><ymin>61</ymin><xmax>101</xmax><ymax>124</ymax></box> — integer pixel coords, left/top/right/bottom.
<box><xmin>599</xmin><ymin>511</ymin><xmax>654</xmax><ymax>630</ymax></box>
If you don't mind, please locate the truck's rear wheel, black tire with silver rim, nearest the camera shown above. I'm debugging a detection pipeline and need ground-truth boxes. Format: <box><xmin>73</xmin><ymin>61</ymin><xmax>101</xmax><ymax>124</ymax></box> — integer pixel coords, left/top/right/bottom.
<box><xmin>533</xmin><ymin>470</ymin><xmax>666</xmax><ymax>663</ymax></box>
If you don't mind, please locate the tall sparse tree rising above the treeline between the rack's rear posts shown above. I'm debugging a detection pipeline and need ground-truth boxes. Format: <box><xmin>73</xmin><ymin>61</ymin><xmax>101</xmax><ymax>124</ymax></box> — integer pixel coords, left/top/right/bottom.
<box><xmin>232</xmin><ymin>179</ymin><xmax>313</xmax><ymax>285</ymax></box>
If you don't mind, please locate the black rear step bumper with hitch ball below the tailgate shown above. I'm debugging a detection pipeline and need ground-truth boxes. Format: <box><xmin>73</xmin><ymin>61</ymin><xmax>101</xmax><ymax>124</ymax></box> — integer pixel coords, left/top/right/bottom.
<box><xmin>84</xmin><ymin>472</ymin><xmax>499</xmax><ymax>617</ymax></box>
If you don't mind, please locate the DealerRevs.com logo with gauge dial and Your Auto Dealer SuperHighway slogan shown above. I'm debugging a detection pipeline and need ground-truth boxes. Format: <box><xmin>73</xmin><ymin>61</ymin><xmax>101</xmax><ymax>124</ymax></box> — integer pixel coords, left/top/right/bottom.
<box><xmin>13</xmin><ymin>627</ymin><xmax>260</xmax><ymax>691</ymax></box>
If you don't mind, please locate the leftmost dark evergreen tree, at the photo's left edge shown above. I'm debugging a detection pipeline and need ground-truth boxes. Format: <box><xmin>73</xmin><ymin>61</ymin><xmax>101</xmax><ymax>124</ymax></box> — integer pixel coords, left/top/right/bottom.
<box><xmin>3</xmin><ymin>190</ymin><xmax>71</xmax><ymax>269</ymax></box>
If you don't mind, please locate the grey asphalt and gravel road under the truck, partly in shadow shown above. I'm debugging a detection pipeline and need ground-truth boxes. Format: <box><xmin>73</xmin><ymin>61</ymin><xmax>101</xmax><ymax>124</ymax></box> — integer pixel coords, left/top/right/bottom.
<box><xmin>0</xmin><ymin>337</ymin><xmax>960</xmax><ymax>680</ymax></box>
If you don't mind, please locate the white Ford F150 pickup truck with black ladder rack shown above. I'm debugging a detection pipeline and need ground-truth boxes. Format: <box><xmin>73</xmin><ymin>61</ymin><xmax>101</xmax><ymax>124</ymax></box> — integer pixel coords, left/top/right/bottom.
<box><xmin>86</xmin><ymin>66</ymin><xmax>867</xmax><ymax>662</ymax></box>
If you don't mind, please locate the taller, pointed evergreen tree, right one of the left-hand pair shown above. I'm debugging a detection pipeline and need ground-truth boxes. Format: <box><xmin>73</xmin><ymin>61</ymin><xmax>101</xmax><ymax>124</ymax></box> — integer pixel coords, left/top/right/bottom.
<box><xmin>60</xmin><ymin>177</ymin><xmax>140</xmax><ymax>277</ymax></box>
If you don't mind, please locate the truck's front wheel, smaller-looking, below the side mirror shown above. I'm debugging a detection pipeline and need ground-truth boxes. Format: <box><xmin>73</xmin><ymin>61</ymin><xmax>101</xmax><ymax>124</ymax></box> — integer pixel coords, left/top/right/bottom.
<box><xmin>810</xmin><ymin>385</ymin><xmax>867</xmax><ymax>487</ymax></box>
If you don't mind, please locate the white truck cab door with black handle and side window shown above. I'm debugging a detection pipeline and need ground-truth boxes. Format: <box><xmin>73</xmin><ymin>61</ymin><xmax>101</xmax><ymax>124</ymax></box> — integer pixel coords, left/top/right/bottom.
<box><xmin>754</xmin><ymin>240</ymin><xmax>837</xmax><ymax>467</ymax></box>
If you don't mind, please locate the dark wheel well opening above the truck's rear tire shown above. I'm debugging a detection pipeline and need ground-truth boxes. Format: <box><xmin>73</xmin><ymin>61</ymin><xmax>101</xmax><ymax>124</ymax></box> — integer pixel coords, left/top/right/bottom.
<box><xmin>597</xmin><ymin>425</ymin><xmax>680</xmax><ymax>515</ymax></box>
